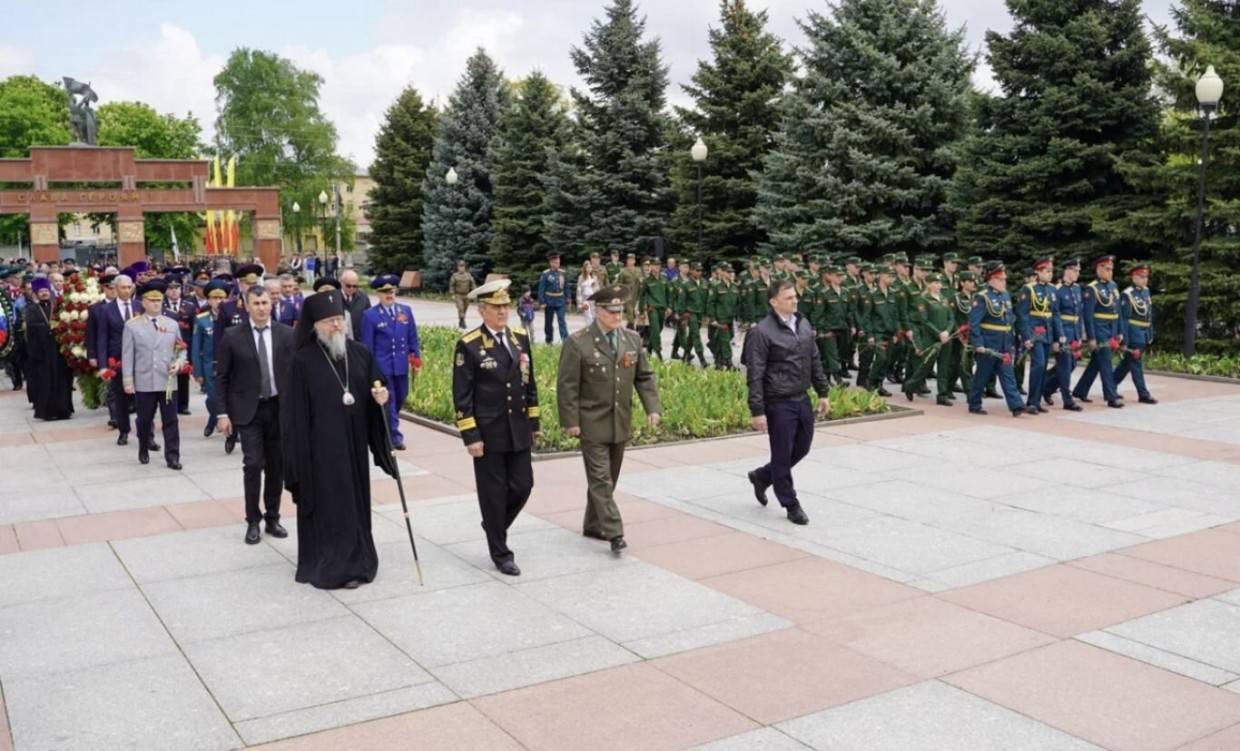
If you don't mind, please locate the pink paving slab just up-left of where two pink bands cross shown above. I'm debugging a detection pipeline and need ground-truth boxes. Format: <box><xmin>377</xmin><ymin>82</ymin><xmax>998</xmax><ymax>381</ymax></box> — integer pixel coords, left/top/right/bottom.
<box><xmin>702</xmin><ymin>556</ymin><xmax>926</xmax><ymax>623</ymax></box>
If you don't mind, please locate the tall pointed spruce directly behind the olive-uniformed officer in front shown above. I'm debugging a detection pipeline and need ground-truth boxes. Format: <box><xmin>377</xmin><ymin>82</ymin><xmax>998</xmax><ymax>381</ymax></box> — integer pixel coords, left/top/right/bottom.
<box><xmin>547</xmin><ymin>0</ymin><xmax>671</xmax><ymax>259</ymax></box>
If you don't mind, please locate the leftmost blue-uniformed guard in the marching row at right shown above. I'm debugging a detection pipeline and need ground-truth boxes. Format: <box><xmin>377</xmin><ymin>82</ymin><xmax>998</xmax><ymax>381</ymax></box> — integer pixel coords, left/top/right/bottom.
<box><xmin>968</xmin><ymin>261</ymin><xmax>1024</xmax><ymax>418</ymax></box>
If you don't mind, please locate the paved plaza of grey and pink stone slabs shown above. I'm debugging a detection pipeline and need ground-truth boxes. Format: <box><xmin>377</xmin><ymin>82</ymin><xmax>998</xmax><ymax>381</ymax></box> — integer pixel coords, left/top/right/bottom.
<box><xmin>0</xmin><ymin>297</ymin><xmax>1240</xmax><ymax>751</ymax></box>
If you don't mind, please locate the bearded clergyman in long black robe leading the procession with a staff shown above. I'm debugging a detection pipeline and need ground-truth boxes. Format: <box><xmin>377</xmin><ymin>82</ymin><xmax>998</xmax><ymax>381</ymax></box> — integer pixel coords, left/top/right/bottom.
<box><xmin>280</xmin><ymin>290</ymin><xmax>398</xmax><ymax>589</ymax></box>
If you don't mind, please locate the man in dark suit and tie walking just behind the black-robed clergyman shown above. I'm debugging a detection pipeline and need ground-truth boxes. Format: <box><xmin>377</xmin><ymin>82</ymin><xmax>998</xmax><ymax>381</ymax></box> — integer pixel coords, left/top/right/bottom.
<box><xmin>216</xmin><ymin>285</ymin><xmax>293</xmax><ymax>545</ymax></box>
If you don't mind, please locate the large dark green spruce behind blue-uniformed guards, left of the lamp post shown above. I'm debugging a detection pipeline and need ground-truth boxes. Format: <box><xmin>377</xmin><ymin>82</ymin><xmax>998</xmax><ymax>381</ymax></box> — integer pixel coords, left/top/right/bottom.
<box><xmin>954</xmin><ymin>0</ymin><xmax>1158</xmax><ymax>268</ymax></box>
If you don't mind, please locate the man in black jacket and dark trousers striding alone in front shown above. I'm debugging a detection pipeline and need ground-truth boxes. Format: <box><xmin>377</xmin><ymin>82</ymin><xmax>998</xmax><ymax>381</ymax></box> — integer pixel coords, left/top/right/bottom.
<box><xmin>743</xmin><ymin>280</ymin><xmax>831</xmax><ymax>524</ymax></box>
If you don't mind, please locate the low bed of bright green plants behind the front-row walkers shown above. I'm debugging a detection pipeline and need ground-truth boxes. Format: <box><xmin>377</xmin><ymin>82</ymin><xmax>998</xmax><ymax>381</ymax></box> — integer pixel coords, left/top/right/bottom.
<box><xmin>405</xmin><ymin>327</ymin><xmax>888</xmax><ymax>451</ymax></box>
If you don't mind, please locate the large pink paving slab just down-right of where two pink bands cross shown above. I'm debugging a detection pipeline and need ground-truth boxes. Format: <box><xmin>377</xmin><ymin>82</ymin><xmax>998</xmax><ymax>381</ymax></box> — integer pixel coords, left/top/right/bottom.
<box><xmin>944</xmin><ymin>639</ymin><xmax>1240</xmax><ymax>751</ymax></box>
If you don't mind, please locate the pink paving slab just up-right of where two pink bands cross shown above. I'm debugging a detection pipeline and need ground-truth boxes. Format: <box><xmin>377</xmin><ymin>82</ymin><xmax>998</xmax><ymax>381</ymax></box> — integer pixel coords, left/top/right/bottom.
<box><xmin>936</xmin><ymin>565</ymin><xmax>1188</xmax><ymax>637</ymax></box>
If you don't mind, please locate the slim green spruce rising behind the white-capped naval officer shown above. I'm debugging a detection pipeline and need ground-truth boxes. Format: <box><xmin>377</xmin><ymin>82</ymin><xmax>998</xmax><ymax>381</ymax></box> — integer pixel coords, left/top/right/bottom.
<box><xmin>491</xmin><ymin>71</ymin><xmax>568</xmax><ymax>279</ymax></box>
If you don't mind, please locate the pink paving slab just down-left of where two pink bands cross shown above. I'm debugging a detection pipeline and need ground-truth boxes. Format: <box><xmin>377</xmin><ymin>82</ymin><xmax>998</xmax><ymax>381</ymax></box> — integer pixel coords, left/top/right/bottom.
<box><xmin>651</xmin><ymin>630</ymin><xmax>918</xmax><ymax>724</ymax></box>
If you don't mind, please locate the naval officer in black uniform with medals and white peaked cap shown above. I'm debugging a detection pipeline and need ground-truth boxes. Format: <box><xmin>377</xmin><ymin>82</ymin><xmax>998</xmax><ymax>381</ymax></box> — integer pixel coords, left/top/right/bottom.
<box><xmin>453</xmin><ymin>279</ymin><xmax>539</xmax><ymax>576</ymax></box>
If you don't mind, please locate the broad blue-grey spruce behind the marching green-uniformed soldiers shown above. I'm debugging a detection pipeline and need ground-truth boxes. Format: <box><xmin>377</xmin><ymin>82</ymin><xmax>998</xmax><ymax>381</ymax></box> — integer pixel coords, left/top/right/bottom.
<box><xmin>754</xmin><ymin>0</ymin><xmax>973</xmax><ymax>259</ymax></box>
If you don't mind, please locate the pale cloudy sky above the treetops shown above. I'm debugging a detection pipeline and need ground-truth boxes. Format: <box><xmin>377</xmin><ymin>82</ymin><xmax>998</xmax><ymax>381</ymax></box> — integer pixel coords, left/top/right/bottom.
<box><xmin>0</xmin><ymin>0</ymin><xmax>1173</xmax><ymax>166</ymax></box>
